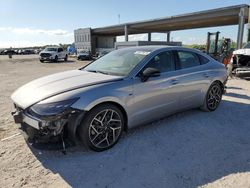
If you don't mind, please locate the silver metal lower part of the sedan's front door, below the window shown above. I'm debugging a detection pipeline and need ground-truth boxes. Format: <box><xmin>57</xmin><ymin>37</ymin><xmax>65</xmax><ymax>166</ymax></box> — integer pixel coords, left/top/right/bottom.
<box><xmin>132</xmin><ymin>74</ymin><xmax>180</xmax><ymax>124</ymax></box>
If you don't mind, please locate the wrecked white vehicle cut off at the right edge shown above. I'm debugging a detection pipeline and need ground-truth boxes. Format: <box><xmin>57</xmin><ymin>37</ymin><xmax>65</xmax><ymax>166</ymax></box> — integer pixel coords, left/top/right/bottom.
<box><xmin>227</xmin><ymin>42</ymin><xmax>250</xmax><ymax>78</ymax></box>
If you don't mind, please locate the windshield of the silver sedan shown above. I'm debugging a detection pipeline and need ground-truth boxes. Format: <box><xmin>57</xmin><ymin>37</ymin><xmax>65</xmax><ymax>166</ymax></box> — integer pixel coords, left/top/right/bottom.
<box><xmin>84</xmin><ymin>48</ymin><xmax>150</xmax><ymax>76</ymax></box>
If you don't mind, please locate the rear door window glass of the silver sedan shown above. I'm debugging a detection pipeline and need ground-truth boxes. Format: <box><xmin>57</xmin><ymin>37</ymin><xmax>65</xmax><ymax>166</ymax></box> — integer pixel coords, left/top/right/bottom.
<box><xmin>177</xmin><ymin>51</ymin><xmax>200</xmax><ymax>69</ymax></box>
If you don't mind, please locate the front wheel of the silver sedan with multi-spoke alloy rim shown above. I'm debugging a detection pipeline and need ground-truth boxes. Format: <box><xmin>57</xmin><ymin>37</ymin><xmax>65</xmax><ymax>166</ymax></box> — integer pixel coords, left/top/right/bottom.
<box><xmin>78</xmin><ymin>104</ymin><xmax>124</xmax><ymax>152</ymax></box>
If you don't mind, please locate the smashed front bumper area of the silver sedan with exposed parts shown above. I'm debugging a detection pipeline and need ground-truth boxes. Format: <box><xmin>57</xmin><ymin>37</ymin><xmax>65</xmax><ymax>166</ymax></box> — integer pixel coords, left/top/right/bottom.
<box><xmin>12</xmin><ymin>106</ymin><xmax>84</xmax><ymax>142</ymax></box>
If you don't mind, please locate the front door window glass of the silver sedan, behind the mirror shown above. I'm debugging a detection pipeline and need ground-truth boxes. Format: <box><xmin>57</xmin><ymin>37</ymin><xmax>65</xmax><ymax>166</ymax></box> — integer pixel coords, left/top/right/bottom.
<box><xmin>144</xmin><ymin>51</ymin><xmax>175</xmax><ymax>73</ymax></box>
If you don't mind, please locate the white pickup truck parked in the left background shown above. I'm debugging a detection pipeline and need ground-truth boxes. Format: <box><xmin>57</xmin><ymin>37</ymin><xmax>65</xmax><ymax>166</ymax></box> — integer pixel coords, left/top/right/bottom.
<box><xmin>39</xmin><ymin>47</ymin><xmax>68</xmax><ymax>63</ymax></box>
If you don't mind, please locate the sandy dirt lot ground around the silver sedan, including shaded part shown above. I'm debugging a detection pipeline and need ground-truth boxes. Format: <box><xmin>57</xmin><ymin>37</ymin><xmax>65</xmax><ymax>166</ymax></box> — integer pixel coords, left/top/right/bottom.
<box><xmin>0</xmin><ymin>56</ymin><xmax>250</xmax><ymax>188</ymax></box>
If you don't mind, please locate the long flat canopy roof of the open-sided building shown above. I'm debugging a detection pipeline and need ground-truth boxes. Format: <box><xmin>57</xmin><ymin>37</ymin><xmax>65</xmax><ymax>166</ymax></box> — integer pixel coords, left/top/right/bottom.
<box><xmin>92</xmin><ymin>4</ymin><xmax>249</xmax><ymax>36</ymax></box>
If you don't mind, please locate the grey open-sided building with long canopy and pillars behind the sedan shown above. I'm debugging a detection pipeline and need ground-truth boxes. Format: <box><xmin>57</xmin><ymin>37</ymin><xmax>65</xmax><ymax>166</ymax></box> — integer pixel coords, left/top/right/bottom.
<box><xmin>74</xmin><ymin>4</ymin><xmax>250</xmax><ymax>54</ymax></box>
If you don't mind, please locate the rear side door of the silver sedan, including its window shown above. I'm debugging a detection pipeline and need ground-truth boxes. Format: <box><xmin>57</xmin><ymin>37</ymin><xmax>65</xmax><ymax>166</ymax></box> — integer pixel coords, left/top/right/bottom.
<box><xmin>176</xmin><ymin>51</ymin><xmax>211</xmax><ymax>109</ymax></box>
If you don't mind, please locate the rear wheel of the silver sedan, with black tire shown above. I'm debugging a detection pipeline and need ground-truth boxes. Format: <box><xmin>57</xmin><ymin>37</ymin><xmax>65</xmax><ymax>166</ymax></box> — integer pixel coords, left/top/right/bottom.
<box><xmin>201</xmin><ymin>82</ymin><xmax>223</xmax><ymax>112</ymax></box>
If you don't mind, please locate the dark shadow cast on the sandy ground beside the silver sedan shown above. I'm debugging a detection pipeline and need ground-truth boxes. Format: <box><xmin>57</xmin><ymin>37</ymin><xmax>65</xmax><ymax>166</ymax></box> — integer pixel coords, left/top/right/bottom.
<box><xmin>27</xmin><ymin>100</ymin><xmax>250</xmax><ymax>188</ymax></box>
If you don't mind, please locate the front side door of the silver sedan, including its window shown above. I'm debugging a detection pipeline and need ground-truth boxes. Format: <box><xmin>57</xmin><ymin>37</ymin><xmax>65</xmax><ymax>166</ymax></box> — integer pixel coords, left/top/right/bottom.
<box><xmin>132</xmin><ymin>51</ymin><xmax>180</xmax><ymax>124</ymax></box>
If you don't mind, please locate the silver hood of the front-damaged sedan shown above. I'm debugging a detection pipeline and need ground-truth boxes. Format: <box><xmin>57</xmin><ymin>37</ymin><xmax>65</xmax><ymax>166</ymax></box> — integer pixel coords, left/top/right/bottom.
<box><xmin>11</xmin><ymin>70</ymin><xmax>122</xmax><ymax>109</ymax></box>
